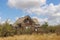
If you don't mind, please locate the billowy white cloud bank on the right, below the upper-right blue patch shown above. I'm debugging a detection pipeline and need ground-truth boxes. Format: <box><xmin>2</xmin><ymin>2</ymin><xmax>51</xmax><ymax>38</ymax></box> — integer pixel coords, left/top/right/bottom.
<box><xmin>31</xmin><ymin>4</ymin><xmax>60</xmax><ymax>25</ymax></box>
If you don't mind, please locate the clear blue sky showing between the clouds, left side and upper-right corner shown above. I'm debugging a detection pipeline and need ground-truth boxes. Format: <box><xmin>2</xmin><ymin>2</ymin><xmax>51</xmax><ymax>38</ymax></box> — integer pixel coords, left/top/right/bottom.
<box><xmin>0</xmin><ymin>0</ymin><xmax>60</xmax><ymax>24</ymax></box>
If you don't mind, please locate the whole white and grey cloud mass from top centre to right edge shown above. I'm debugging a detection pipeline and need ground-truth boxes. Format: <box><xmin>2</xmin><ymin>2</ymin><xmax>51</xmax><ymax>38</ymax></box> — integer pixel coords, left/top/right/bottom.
<box><xmin>8</xmin><ymin>0</ymin><xmax>60</xmax><ymax>24</ymax></box>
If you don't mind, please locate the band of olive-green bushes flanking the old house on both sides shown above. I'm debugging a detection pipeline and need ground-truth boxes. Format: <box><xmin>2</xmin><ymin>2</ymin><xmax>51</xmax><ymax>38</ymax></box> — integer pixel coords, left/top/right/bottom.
<box><xmin>0</xmin><ymin>22</ymin><xmax>60</xmax><ymax>37</ymax></box>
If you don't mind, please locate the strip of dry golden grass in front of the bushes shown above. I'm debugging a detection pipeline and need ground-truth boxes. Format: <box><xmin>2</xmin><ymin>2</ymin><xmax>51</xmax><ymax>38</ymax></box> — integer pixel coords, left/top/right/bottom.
<box><xmin>0</xmin><ymin>34</ymin><xmax>60</xmax><ymax>40</ymax></box>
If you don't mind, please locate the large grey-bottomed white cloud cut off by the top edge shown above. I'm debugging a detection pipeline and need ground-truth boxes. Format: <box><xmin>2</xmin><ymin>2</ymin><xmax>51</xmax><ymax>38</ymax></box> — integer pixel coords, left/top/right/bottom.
<box><xmin>8</xmin><ymin>0</ymin><xmax>46</xmax><ymax>9</ymax></box>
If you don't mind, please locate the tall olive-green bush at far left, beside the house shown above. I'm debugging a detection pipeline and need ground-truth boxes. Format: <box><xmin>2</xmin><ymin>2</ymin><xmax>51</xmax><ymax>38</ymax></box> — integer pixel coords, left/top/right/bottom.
<box><xmin>0</xmin><ymin>22</ymin><xmax>14</xmax><ymax>37</ymax></box>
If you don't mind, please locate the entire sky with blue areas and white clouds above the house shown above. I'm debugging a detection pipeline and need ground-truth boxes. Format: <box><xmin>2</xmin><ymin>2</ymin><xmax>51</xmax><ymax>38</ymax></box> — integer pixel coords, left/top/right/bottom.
<box><xmin>0</xmin><ymin>0</ymin><xmax>60</xmax><ymax>25</ymax></box>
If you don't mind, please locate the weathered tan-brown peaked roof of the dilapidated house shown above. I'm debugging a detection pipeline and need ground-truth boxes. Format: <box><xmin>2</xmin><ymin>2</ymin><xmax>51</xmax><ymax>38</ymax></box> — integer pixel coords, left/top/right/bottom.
<box><xmin>13</xmin><ymin>15</ymin><xmax>39</xmax><ymax>26</ymax></box>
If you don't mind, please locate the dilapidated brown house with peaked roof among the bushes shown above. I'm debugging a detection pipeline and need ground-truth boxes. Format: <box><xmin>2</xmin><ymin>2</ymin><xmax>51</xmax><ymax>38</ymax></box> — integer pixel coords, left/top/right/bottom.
<box><xmin>13</xmin><ymin>15</ymin><xmax>43</xmax><ymax>32</ymax></box>
